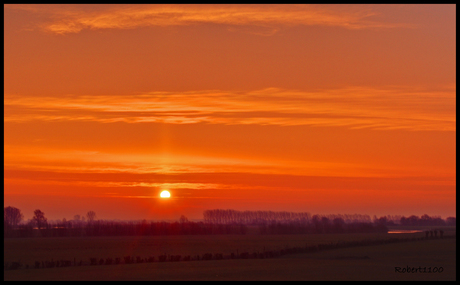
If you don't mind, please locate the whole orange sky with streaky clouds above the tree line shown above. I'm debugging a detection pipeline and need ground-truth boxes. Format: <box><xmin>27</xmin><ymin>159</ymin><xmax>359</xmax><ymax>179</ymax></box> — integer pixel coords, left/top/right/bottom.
<box><xmin>4</xmin><ymin>4</ymin><xmax>456</xmax><ymax>220</ymax></box>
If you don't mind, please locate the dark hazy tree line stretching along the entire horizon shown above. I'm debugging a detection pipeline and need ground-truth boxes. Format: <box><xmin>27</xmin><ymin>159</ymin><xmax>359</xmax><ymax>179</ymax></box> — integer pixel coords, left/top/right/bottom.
<box><xmin>4</xmin><ymin>204</ymin><xmax>456</xmax><ymax>237</ymax></box>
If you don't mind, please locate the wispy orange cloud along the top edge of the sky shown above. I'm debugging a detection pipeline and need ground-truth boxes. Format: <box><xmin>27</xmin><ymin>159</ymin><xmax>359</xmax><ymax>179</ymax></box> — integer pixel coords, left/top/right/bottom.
<box><xmin>7</xmin><ymin>5</ymin><xmax>414</xmax><ymax>34</ymax></box>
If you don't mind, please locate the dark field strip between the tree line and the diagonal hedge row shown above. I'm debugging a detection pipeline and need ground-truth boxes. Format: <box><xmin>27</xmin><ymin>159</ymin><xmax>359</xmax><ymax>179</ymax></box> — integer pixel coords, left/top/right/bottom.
<box><xmin>3</xmin><ymin>233</ymin><xmax>434</xmax><ymax>266</ymax></box>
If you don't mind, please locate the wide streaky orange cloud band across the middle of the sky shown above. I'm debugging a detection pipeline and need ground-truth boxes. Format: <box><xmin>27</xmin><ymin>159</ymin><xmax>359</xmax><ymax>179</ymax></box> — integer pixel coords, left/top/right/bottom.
<box><xmin>4</xmin><ymin>87</ymin><xmax>456</xmax><ymax>131</ymax></box>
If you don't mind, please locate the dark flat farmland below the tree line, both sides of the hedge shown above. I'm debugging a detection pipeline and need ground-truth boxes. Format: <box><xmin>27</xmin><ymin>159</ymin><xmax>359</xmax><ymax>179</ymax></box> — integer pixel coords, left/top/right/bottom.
<box><xmin>4</xmin><ymin>230</ymin><xmax>456</xmax><ymax>280</ymax></box>
